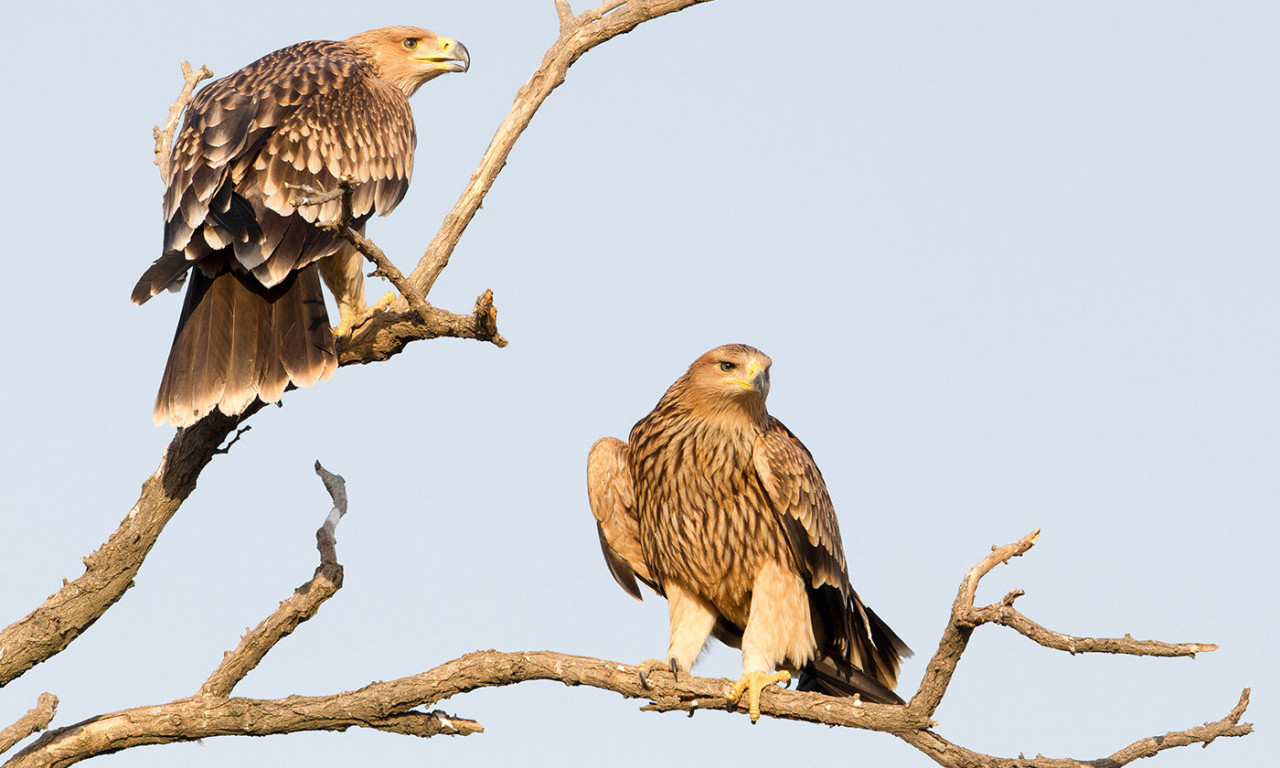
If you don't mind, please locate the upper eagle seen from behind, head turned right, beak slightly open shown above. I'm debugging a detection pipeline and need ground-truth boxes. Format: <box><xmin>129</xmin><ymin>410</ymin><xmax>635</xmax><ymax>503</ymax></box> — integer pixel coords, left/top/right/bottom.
<box><xmin>133</xmin><ymin>27</ymin><xmax>470</xmax><ymax>426</ymax></box>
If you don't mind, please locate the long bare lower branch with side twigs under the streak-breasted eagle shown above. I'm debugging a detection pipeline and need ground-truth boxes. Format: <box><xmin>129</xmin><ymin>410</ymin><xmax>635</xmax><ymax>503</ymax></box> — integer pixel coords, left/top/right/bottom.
<box><xmin>6</xmin><ymin>535</ymin><xmax>1253</xmax><ymax>768</ymax></box>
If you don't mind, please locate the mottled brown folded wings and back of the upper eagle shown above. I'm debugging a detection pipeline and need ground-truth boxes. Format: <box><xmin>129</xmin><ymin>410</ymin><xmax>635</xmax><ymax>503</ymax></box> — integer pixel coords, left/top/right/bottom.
<box><xmin>133</xmin><ymin>41</ymin><xmax>417</xmax><ymax>303</ymax></box>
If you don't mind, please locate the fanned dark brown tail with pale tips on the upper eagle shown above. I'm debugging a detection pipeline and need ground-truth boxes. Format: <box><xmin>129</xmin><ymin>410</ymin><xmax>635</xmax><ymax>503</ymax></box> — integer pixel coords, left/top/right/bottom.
<box><xmin>152</xmin><ymin>259</ymin><xmax>338</xmax><ymax>426</ymax></box>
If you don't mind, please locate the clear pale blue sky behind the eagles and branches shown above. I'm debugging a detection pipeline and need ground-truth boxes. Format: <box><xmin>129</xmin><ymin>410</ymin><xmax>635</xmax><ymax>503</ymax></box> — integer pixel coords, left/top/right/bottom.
<box><xmin>0</xmin><ymin>0</ymin><xmax>1280</xmax><ymax>768</ymax></box>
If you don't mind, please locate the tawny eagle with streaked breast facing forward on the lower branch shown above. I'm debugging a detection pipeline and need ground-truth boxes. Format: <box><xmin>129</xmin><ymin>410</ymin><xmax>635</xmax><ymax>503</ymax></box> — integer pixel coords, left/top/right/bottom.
<box><xmin>586</xmin><ymin>344</ymin><xmax>911</xmax><ymax>722</ymax></box>
